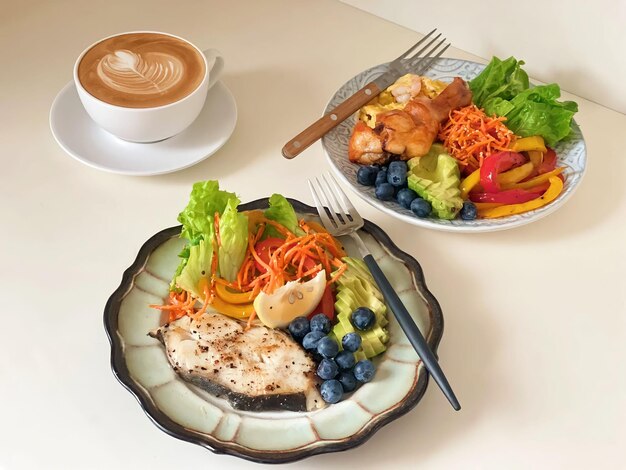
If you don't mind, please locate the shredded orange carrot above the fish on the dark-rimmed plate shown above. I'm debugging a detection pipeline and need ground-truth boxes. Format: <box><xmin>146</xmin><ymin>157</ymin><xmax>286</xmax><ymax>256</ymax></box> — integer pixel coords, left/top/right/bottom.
<box><xmin>151</xmin><ymin>214</ymin><xmax>347</xmax><ymax>323</ymax></box>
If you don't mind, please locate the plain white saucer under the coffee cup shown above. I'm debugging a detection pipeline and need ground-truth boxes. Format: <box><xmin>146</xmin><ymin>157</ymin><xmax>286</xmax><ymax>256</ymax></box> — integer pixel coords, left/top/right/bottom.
<box><xmin>50</xmin><ymin>82</ymin><xmax>237</xmax><ymax>175</ymax></box>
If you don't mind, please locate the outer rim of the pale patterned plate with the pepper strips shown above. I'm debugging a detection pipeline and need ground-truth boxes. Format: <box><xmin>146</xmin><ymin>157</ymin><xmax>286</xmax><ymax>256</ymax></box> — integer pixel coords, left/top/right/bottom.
<box><xmin>321</xmin><ymin>57</ymin><xmax>588</xmax><ymax>233</ymax></box>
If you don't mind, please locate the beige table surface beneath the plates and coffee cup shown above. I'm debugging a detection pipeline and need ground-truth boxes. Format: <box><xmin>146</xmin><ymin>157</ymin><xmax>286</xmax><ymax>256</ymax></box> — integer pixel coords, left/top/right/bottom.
<box><xmin>0</xmin><ymin>0</ymin><xmax>626</xmax><ymax>469</ymax></box>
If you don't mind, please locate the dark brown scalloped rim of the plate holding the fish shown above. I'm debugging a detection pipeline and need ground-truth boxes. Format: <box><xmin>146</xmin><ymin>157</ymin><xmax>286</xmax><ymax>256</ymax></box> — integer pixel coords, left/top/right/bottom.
<box><xmin>103</xmin><ymin>198</ymin><xmax>444</xmax><ymax>463</ymax></box>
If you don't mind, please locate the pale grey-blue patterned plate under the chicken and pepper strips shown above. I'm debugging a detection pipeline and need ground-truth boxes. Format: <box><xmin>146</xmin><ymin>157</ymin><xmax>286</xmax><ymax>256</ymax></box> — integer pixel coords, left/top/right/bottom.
<box><xmin>322</xmin><ymin>59</ymin><xmax>587</xmax><ymax>232</ymax></box>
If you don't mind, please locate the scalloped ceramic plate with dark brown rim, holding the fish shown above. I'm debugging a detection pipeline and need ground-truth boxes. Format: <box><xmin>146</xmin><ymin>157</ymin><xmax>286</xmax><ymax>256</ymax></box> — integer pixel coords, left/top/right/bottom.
<box><xmin>104</xmin><ymin>199</ymin><xmax>443</xmax><ymax>463</ymax></box>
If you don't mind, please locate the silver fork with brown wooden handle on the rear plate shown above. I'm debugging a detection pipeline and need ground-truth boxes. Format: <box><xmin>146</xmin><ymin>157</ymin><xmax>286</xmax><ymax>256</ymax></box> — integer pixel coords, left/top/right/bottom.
<box><xmin>282</xmin><ymin>28</ymin><xmax>450</xmax><ymax>158</ymax></box>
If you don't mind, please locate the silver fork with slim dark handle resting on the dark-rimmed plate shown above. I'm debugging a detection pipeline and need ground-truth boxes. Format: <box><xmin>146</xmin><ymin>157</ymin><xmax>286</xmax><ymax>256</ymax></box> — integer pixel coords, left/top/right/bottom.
<box><xmin>308</xmin><ymin>175</ymin><xmax>461</xmax><ymax>411</ymax></box>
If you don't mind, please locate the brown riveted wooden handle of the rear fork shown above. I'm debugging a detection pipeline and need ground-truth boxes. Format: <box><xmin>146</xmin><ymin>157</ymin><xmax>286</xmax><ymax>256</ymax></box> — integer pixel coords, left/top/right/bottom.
<box><xmin>283</xmin><ymin>82</ymin><xmax>381</xmax><ymax>159</ymax></box>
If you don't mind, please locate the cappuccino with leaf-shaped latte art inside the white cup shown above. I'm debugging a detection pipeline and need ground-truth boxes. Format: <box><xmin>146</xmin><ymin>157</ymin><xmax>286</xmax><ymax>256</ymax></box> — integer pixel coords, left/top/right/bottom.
<box><xmin>77</xmin><ymin>32</ymin><xmax>206</xmax><ymax>108</ymax></box>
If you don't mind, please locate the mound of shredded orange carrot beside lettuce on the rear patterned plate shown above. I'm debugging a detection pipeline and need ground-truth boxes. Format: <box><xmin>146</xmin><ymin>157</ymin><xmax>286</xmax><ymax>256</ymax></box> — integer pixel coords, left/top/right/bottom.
<box><xmin>439</xmin><ymin>104</ymin><xmax>515</xmax><ymax>174</ymax></box>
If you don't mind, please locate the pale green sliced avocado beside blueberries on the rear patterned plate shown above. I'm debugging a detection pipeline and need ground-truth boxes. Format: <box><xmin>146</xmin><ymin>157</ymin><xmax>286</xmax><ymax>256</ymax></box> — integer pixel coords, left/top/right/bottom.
<box><xmin>408</xmin><ymin>144</ymin><xmax>463</xmax><ymax>219</ymax></box>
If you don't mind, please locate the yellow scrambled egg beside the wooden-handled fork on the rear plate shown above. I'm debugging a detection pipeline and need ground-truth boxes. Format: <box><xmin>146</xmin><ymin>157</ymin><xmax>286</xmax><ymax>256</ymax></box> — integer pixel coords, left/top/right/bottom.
<box><xmin>359</xmin><ymin>73</ymin><xmax>448</xmax><ymax>129</ymax></box>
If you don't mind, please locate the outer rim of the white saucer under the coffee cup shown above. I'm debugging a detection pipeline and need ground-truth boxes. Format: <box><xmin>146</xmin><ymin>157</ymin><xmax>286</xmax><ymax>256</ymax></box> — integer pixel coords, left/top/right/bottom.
<box><xmin>48</xmin><ymin>80</ymin><xmax>239</xmax><ymax>176</ymax></box>
